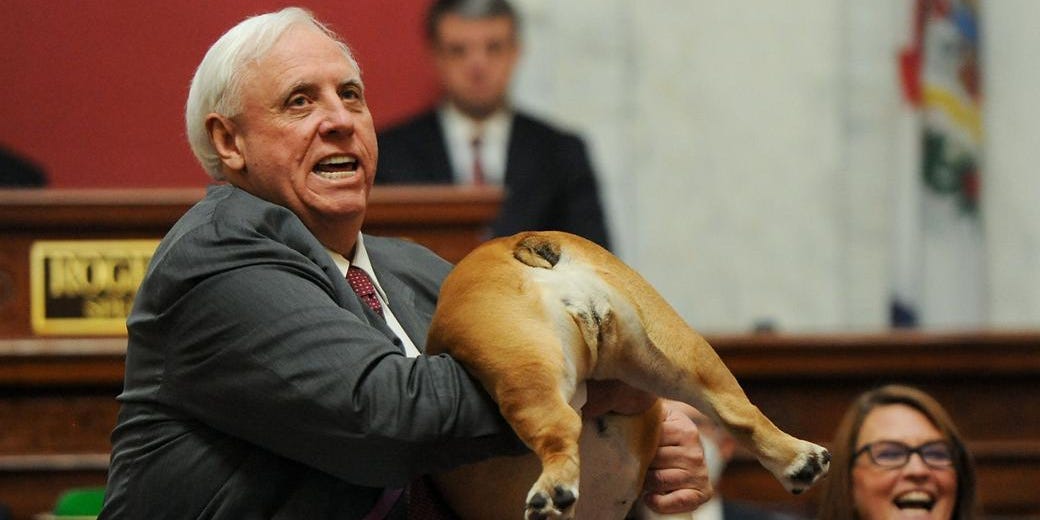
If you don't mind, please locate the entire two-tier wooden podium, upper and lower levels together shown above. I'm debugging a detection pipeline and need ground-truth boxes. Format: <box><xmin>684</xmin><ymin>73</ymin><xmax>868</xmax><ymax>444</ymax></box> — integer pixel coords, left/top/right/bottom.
<box><xmin>0</xmin><ymin>187</ymin><xmax>1040</xmax><ymax>520</ymax></box>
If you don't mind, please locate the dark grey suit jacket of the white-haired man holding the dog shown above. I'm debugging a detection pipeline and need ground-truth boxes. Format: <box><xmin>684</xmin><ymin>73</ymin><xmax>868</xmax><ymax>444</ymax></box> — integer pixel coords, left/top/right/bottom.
<box><xmin>101</xmin><ymin>186</ymin><xmax>522</xmax><ymax>520</ymax></box>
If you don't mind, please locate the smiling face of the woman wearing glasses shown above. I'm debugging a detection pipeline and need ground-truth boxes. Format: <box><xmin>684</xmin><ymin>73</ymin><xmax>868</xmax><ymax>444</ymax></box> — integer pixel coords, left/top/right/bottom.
<box><xmin>852</xmin><ymin>405</ymin><xmax>957</xmax><ymax>520</ymax></box>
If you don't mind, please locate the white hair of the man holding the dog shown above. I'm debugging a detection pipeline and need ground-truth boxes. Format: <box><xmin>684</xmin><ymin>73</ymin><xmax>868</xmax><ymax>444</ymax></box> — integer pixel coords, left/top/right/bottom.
<box><xmin>184</xmin><ymin>7</ymin><xmax>360</xmax><ymax>181</ymax></box>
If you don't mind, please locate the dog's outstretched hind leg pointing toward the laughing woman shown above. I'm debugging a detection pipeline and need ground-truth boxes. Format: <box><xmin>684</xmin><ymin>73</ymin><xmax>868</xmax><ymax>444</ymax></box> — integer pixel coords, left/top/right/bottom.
<box><xmin>544</xmin><ymin>233</ymin><xmax>830</xmax><ymax>493</ymax></box>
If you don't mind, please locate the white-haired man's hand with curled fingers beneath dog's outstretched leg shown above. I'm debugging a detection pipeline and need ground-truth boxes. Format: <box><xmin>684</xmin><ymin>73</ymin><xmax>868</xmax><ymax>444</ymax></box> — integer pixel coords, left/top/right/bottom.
<box><xmin>643</xmin><ymin>399</ymin><xmax>713</xmax><ymax>515</ymax></box>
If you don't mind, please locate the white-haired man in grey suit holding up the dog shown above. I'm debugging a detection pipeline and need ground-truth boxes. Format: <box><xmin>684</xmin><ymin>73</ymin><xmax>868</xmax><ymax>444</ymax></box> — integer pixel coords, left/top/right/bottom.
<box><xmin>100</xmin><ymin>8</ymin><xmax>706</xmax><ymax>519</ymax></box>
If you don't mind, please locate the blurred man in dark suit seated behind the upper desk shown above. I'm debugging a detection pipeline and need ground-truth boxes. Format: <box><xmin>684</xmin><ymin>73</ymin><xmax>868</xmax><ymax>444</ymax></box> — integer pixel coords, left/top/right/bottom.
<box><xmin>376</xmin><ymin>0</ymin><xmax>609</xmax><ymax>248</ymax></box>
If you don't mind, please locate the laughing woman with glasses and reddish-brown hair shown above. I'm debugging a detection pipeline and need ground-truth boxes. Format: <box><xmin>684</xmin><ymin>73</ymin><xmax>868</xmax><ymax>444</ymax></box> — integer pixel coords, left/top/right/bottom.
<box><xmin>820</xmin><ymin>385</ymin><xmax>976</xmax><ymax>520</ymax></box>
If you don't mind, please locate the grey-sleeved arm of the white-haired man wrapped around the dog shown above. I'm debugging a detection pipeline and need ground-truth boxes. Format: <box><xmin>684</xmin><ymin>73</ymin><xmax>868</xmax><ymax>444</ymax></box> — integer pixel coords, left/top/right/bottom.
<box><xmin>155</xmin><ymin>260</ymin><xmax>520</xmax><ymax>486</ymax></box>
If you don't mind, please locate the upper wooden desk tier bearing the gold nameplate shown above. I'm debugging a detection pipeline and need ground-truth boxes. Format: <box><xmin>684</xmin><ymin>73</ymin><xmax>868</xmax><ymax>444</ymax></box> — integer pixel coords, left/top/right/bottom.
<box><xmin>0</xmin><ymin>186</ymin><xmax>501</xmax><ymax>338</ymax></box>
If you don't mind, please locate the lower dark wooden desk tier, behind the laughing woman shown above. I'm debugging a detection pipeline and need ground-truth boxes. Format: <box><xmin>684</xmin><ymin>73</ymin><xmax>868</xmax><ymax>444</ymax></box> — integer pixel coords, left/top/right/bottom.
<box><xmin>0</xmin><ymin>332</ymin><xmax>1040</xmax><ymax>520</ymax></box>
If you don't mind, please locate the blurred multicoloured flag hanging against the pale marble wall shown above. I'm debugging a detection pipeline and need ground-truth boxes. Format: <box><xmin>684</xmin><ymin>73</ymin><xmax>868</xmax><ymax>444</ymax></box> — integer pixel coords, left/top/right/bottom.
<box><xmin>891</xmin><ymin>0</ymin><xmax>987</xmax><ymax>328</ymax></box>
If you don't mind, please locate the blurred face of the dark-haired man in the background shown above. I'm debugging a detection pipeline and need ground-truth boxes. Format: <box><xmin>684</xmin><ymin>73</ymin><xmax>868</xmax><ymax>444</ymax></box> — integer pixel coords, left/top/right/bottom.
<box><xmin>434</xmin><ymin>14</ymin><xmax>519</xmax><ymax>119</ymax></box>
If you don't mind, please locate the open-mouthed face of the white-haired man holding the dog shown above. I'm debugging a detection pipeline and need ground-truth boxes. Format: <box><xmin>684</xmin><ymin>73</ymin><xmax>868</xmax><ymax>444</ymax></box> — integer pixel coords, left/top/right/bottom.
<box><xmin>211</xmin><ymin>27</ymin><xmax>379</xmax><ymax>231</ymax></box>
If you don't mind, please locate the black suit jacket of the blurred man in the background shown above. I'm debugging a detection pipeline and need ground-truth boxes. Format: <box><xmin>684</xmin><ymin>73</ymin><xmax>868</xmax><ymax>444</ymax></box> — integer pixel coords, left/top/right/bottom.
<box><xmin>375</xmin><ymin>111</ymin><xmax>609</xmax><ymax>248</ymax></box>
